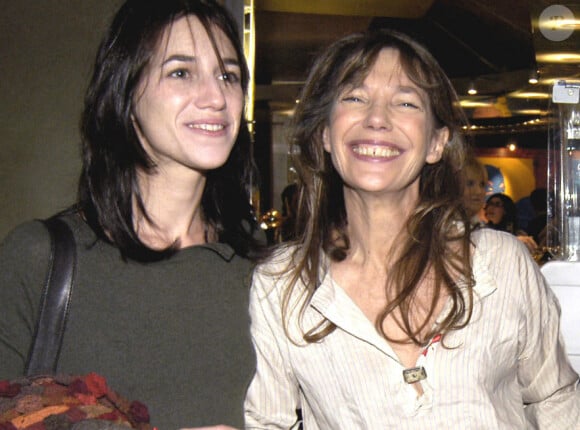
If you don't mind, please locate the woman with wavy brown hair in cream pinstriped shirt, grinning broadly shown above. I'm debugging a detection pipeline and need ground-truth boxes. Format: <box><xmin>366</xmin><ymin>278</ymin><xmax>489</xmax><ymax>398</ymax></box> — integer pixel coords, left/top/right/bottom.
<box><xmin>246</xmin><ymin>30</ymin><xmax>580</xmax><ymax>430</ymax></box>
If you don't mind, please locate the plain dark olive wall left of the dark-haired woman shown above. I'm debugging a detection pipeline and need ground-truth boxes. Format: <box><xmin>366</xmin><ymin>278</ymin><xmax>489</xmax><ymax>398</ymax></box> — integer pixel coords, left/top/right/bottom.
<box><xmin>0</xmin><ymin>0</ymin><xmax>121</xmax><ymax>237</ymax></box>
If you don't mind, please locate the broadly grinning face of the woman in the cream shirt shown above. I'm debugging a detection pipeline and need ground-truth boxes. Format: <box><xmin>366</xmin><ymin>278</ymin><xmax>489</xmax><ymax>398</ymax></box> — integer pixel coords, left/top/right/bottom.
<box><xmin>322</xmin><ymin>49</ymin><xmax>449</xmax><ymax>198</ymax></box>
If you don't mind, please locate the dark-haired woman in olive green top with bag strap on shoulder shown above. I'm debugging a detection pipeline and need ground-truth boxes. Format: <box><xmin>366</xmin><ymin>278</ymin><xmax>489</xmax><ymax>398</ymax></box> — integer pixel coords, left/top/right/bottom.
<box><xmin>0</xmin><ymin>0</ymin><xmax>262</xmax><ymax>429</ymax></box>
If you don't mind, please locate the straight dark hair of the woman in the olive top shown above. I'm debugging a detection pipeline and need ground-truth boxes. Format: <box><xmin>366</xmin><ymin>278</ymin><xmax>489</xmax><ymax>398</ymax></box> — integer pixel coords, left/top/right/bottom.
<box><xmin>77</xmin><ymin>0</ymin><xmax>261</xmax><ymax>262</ymax></box>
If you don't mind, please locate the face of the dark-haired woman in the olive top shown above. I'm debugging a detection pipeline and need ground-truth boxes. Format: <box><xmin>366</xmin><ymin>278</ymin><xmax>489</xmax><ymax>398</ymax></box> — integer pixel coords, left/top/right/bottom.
<box><xmin>133</xmin><ymin>17</ymin><xmax>244</xmax><ymax>189</ymax></box>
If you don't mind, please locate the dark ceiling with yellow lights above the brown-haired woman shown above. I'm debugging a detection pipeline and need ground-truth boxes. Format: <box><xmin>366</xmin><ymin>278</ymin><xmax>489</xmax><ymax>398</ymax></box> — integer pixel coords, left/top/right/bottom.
<box><xmin>249</xmin><ymin>0</ymin><xmax>580</xmax><ymax>144</ymax></box>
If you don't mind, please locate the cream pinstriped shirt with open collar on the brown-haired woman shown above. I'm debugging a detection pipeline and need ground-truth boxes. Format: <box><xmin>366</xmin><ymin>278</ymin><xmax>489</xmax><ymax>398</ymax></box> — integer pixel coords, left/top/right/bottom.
<box><xmin>245</xmin><ymin>229</ymin><xmax>580</xmax><ymax>430</ymax></box>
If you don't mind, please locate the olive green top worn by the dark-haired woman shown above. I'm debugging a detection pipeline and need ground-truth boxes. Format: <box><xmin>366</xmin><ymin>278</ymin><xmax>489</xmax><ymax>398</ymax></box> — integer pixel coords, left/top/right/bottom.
<box><xmin>0</xmin><ymin>215</ymin><xmax>254</xmax><ymax>430</ymax></box>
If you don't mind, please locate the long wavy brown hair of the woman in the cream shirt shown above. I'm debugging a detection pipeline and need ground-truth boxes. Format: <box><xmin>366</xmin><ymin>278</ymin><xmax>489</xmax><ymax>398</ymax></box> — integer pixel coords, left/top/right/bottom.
<box><xmin>283</xmin><ymin>30</ymin><xmax>474</xmax><ymax>345</ymax></box>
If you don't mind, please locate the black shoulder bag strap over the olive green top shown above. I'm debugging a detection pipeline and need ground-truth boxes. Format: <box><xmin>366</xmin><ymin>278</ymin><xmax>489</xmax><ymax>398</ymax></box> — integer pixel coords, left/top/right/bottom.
<box><xmin>26</xmin><ymin>216</ymin><xmax>76</xmax><ymax>376</ymax></box>
